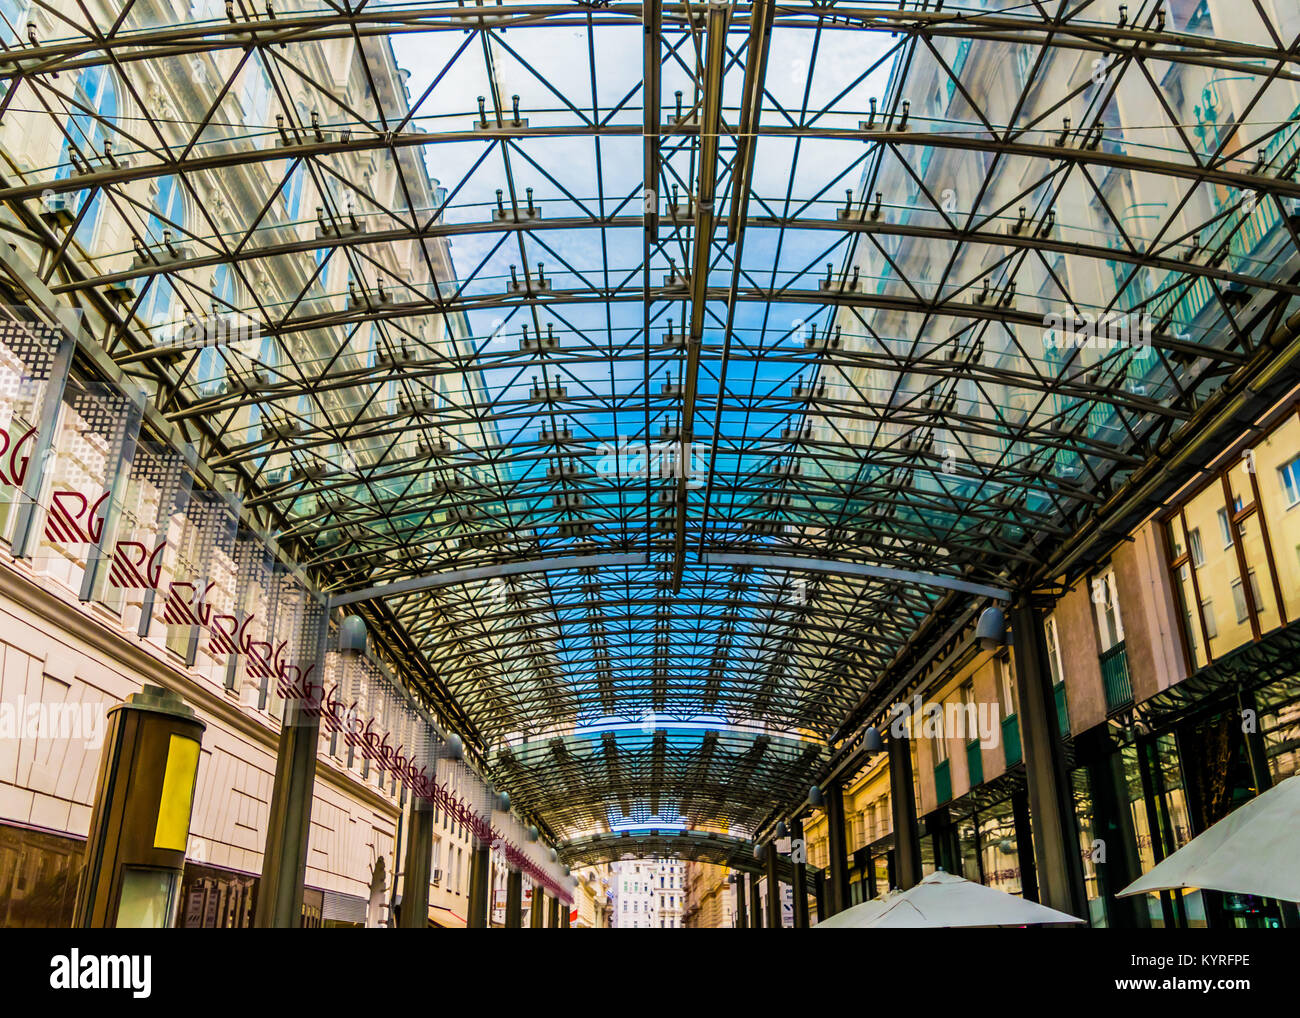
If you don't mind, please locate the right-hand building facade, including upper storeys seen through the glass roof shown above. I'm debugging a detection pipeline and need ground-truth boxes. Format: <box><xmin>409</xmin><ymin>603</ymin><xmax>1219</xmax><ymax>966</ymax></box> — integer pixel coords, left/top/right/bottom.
<box><xmin>780</xmin><ymin>0</ymin><xmax>1300</xmax><ymax>927</ymax></box>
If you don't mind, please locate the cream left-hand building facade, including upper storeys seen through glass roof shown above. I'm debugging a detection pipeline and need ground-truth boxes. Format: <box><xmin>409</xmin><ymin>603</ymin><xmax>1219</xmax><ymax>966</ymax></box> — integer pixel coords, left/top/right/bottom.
<box><xmin>0</xmin><ymin>3</ymin><xmax>512</xmax><ymax>927</ymax></box>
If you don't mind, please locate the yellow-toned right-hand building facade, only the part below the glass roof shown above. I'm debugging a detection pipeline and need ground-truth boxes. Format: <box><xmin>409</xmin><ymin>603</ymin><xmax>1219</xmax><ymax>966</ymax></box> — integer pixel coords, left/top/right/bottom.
<box><xmin>806</xmin><ymin>393</ymin><xmax>1300</xmax><ymax>927</ymax></box>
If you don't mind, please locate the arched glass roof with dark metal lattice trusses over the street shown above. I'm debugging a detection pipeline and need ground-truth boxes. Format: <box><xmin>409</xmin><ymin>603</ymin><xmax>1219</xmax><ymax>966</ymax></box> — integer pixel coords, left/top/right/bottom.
<box><xmin>0</xmin><ymin>0</ymin><xmax>1300</xmax><ymax>837</ymax></box>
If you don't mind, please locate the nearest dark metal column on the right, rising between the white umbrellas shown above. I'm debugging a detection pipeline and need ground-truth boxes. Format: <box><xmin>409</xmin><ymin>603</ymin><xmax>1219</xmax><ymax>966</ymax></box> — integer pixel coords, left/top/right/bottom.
<box><xmin>1011</xmin><ymin>598</ymin><xmax>1088</xmax><ymax>918</ymax></box>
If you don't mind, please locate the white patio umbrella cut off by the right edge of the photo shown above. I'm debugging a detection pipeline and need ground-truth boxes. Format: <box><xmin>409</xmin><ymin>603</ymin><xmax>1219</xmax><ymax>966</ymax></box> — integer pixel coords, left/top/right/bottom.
<box><xmin>1119</xmin><ymin>775</ymin><xmax>1300</xmax><ymax>901</ymax></box>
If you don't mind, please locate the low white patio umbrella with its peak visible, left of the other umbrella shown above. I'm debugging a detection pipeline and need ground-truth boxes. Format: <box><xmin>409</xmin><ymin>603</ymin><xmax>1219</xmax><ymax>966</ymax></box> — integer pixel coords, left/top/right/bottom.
<box><xmin>816</xmin><ymin>870</ymin><xmax>1083</xmax><ymax>930</ymax></box>
